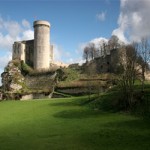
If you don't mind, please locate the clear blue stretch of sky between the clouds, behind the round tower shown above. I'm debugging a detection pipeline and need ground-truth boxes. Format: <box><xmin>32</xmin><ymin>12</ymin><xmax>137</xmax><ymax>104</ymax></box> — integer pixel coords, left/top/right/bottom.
<box><xmin>0</xmin><ymin>0</ymin><xmax>120</xmax><ymax>63</ymax></box>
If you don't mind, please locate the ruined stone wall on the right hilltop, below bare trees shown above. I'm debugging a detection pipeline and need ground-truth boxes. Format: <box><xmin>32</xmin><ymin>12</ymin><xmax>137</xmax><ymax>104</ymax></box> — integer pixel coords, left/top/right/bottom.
<box><xmin>84</xmin><ymin>42</ymin><xmax>122</xmax><ymax>73</ymax></box>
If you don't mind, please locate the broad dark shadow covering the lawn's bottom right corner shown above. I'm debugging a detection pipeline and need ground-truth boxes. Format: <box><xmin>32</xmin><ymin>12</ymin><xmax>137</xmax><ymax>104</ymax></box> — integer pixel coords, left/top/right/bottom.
<box><xmin>74</xmin><ymin>116</ymin><xmax>150</xmax><ymax>150</ymax></box>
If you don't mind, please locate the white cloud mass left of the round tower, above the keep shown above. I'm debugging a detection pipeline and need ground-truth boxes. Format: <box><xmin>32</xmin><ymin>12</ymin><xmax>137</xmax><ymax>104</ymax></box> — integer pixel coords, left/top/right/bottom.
<box><xmin>0</xmin><ymin>17</ymin><xmax>34</xmax><ymax>51</ymax></box>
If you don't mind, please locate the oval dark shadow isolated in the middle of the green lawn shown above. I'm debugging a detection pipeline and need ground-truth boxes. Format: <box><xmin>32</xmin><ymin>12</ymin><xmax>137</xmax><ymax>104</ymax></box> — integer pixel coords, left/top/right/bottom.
<box><xmin>53</xmin><ymin>109</ymin><xmax>106</xmax><ymax>119</ymax></box>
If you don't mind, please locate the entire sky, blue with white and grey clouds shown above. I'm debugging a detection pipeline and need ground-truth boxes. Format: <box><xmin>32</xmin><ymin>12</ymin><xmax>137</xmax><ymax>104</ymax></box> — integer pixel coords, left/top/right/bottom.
<box><xmin>0</xmin><ymin>0</ymin><xmax>150</xmax><ymax>84</ymax></box>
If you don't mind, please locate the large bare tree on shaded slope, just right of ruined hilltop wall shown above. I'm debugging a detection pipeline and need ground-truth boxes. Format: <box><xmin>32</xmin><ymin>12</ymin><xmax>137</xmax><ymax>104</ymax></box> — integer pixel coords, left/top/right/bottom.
<box><xmin>119</xmin><ymin>45</ymin><xmax>138</xmax><ymax>109</ymax></box>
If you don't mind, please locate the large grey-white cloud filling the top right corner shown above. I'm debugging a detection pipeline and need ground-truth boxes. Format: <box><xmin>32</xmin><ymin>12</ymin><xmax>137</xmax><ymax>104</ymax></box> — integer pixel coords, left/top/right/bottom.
<box><xmin>112</xmin><ymin>0</ymin><xmax>150</xmax><ymax>42</ymax></box>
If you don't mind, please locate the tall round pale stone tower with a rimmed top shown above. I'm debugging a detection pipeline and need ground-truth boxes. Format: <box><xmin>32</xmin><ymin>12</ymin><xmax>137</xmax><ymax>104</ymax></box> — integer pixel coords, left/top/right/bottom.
<box><xmin>33</xmin><ymin>20</ymin><xmax>50</xmax><ymax>70</ymax></box>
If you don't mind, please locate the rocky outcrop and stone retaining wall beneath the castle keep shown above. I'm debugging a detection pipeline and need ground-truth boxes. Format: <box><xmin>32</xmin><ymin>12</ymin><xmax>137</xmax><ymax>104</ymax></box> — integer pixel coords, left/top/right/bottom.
<box><xmin>1</xmin><ymin>60</ymin><xmax>56</xmax><ymax>100</ymax></box>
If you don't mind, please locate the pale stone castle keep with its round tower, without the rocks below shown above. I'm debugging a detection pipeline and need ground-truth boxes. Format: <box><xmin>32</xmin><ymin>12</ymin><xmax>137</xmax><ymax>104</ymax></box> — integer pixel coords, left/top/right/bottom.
<box><xmin>12</xmin><ymin>20</ymin><xmax>53</xmax><ymax>70</ymax></box>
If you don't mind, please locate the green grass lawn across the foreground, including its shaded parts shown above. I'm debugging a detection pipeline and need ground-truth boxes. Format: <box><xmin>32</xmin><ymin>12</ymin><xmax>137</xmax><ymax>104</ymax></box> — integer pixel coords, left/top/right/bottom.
<box><xmin>0</xmin><ymin>98</ymin><xmax>150</xmax><ymax>150</ymax></box>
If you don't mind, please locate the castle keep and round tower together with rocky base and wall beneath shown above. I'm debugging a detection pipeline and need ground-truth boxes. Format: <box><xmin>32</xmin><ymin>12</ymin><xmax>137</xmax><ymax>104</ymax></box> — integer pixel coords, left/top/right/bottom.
<box><xmin>1</xmin><ymin>20</ymin><xmax>56</xmax><ymax>99</ymax></box>
